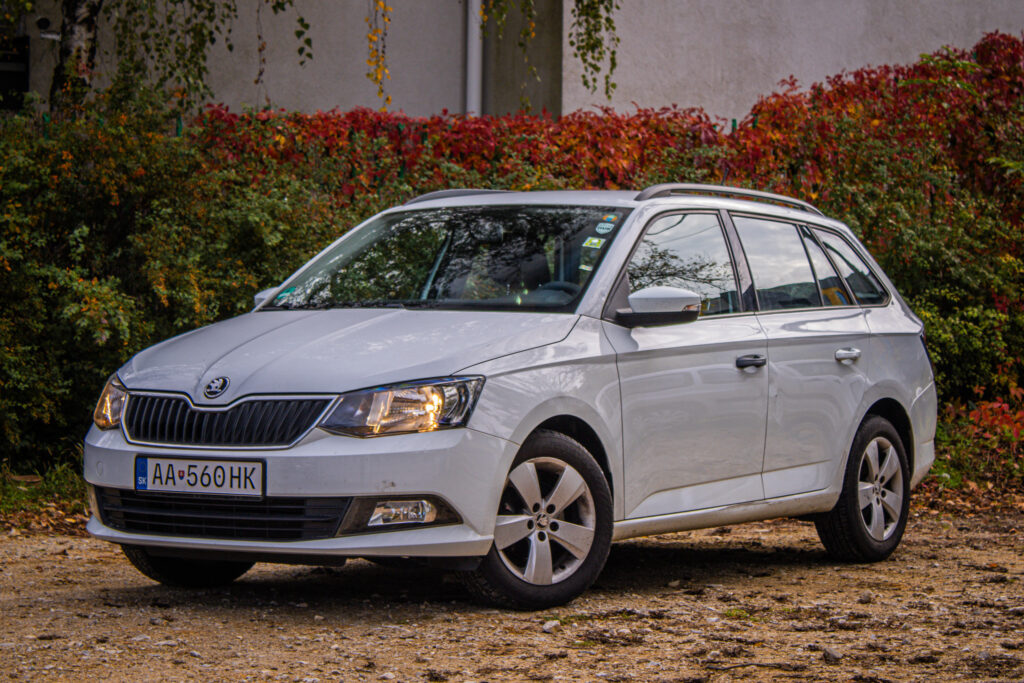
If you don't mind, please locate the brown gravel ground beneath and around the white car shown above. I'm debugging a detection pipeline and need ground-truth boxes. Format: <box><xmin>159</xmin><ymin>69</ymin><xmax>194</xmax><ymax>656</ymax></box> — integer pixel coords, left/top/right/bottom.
<box><xmin>0</xmin><ymin>511</ymin><xmax>1024</xmax><ymax>681</ymax></box>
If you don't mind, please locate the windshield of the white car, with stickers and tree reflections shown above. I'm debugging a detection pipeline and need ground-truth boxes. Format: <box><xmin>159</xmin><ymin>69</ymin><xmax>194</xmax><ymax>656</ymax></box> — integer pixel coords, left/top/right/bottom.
<box><xmin>263</xmin><ymin>206</ymin><xmax>630</xmax><ymax>311</ymax></box>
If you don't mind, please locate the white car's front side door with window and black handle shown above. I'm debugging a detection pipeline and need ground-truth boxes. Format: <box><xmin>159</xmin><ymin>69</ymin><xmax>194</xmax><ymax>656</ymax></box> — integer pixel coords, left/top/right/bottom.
<box><xmin>604</xmin><ymin>212</ymin><xmax>768</xmax><ymax>518</ymax></box>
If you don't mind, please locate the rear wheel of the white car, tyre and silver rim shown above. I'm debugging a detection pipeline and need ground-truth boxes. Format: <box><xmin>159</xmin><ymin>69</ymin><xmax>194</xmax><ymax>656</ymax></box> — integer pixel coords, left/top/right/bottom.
<box><xmin>814</xmin><ymin>415</ymin><xmax>910</xmax><ymax>562</ymax></box>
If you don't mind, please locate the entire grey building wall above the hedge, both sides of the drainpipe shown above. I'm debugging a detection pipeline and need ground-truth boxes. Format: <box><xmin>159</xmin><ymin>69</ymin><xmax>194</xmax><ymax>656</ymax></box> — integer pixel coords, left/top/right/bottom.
<box><xmin>14</xmin><ymin>0</ymin><xmax>1024</xmax><ymax>119</ymax></box>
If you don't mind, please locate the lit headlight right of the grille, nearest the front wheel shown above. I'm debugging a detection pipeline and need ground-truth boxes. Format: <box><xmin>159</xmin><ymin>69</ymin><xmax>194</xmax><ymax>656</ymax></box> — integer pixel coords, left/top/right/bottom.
<box><xmin>319</xmin><ymin>377</ymin><xmax>483</xmax><ymax>436</ymax></box>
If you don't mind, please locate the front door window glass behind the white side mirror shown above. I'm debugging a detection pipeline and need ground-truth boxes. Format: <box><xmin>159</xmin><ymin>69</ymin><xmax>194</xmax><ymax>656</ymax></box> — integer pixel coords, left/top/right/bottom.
<box><xmin>627</xmin><ymin>213</ymin><xmax>739</xmax><ymax>315</ymax></box>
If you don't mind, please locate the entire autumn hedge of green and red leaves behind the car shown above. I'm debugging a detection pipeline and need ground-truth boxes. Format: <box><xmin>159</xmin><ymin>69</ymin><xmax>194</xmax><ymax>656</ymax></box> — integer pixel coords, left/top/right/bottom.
<box><xmin>0</xmin><ymin>34</ymin><xmax>1024</xmax><ymax>481</ymax></box>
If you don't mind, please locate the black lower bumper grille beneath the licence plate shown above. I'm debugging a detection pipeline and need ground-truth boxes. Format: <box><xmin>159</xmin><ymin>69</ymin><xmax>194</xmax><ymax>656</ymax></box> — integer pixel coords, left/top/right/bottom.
<box><xmin>96</xmin><ymin>487</ymin><xmax>351</xmax><ymax>541</ymax></box>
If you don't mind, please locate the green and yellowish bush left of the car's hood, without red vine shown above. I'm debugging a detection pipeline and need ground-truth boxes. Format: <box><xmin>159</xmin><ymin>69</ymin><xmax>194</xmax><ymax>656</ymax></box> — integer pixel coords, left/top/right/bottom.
<box><xmin>0</xmin><ymin>85</ymin><xmax>351</xmax><ymax>470</ymax></box>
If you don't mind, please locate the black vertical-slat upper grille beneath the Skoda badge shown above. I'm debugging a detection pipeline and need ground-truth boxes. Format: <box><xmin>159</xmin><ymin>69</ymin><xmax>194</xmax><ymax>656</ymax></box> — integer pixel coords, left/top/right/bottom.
<box><xmin>124</xmin><ymin>394</ymin><xmax>330</xmax><ymax>446</ymax></box>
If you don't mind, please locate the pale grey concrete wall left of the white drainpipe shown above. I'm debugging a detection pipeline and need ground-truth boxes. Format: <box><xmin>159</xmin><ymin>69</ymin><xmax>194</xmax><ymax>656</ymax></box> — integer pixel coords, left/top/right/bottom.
<box><xmin>27</xmin><ymin>0</ymin><xmax>466</xmax><ymax>116</ymax></box>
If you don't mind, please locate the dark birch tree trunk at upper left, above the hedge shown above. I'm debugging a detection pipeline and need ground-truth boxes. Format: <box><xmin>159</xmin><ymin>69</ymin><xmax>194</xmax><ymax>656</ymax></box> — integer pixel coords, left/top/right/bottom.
<box><xmin>50</xmin><ymin>0</ymin><xmax>103</xmax><ymax>113</ymax></box>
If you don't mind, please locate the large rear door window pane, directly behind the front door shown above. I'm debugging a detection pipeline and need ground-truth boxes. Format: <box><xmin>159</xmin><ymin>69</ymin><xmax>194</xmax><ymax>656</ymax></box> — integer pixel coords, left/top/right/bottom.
<box><xmin>732</xmin><ymin>216</ymin><xmax>821</xmax><ymax>310</ymax></box>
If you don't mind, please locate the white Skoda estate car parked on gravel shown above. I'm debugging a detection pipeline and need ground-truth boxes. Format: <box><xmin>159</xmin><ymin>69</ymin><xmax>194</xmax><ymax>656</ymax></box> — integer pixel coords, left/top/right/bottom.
<box><xmin>85</xmin><ymin>184</ymin><xmax>936</xmax><ymax>608</ymax></box>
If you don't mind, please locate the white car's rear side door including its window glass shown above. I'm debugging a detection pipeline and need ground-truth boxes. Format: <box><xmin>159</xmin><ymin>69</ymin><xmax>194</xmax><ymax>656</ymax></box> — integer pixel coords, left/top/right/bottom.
<box><xmin>732</xmin><ymin>215</ymin><xmax>868</xmax><ymax>499</ymax></box>
